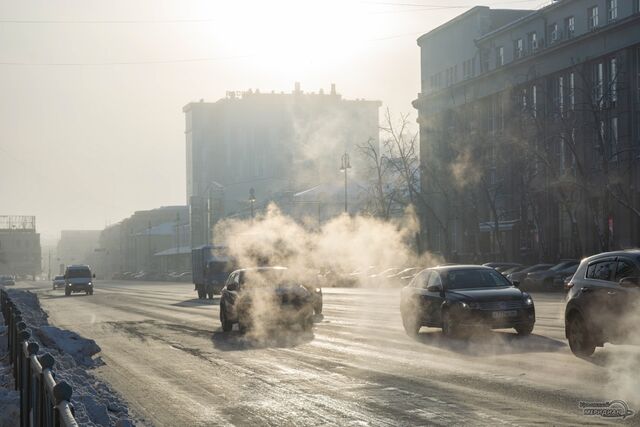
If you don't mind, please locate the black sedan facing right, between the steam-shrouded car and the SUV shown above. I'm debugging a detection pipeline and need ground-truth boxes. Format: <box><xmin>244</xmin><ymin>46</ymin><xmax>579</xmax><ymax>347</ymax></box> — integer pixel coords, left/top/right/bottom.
<box><xmin>400</xmin><ymin>265</ymin><xmax>535</xmax><ymax>336</ymax></box>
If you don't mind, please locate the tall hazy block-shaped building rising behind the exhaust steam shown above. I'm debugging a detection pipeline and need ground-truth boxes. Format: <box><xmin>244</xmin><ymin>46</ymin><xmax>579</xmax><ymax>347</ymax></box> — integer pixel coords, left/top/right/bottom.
<box><xmin>183</xmin><ymin>83</ymin><xmax>380</xmax><ymax>246</ymax></box>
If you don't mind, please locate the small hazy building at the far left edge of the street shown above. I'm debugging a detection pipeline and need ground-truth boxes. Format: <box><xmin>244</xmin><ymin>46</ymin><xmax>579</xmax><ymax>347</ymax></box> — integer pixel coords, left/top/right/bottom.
<box><xmin>0</xmin><ymin>215</ymin><xmax>42</xmax><ymax>278</ymax></box>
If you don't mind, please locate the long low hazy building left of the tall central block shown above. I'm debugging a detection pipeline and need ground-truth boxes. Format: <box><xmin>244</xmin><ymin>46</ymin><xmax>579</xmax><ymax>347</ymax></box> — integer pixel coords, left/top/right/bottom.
<box><xmin>94</xmin><ymin>206</ymin><xmax>191</xmax><ymax>278</ymax></box>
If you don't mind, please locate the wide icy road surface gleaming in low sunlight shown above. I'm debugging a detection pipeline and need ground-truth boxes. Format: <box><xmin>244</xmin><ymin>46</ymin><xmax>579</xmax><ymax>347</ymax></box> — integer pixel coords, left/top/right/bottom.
<box><xmin>11</xmin><ymin>281</ymin><xmax>640</xmax><ymax>426</ymax></box>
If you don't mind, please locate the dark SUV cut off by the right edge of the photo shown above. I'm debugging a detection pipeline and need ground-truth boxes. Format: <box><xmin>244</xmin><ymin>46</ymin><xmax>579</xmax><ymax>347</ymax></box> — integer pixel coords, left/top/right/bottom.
<box><xmin>564</xmin><ymin>249</ymin><xmax>640</xmax><ymax>357</ymax></box>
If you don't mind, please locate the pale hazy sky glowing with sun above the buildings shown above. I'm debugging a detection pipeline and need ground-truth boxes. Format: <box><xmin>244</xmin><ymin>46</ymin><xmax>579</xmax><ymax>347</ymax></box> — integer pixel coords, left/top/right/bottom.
<box><xmin>0</xmin><ymin>0</ymin><xmax>543</xmax><ymax>242</ymax></box>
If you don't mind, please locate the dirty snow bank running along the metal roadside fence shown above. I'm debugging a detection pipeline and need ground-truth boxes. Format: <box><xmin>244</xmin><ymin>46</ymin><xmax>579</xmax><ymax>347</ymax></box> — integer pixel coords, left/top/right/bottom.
<box><xmin>0</xmin><ymin>289</ymin><xmax>136</xmax><ymax>427</ymax></box>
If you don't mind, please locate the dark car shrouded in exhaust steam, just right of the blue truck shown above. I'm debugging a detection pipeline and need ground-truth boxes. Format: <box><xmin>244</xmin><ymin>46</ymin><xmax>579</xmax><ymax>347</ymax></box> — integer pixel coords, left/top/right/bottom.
<box><xmin>220</xmin><ymin>267</ymin><xmax>315</xmax><ymax>333</ymax></box>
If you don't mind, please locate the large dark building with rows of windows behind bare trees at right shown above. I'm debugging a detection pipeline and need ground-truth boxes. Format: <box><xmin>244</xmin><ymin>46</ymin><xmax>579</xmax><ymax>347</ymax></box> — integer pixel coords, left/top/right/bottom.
<box><xmin>413</xmin><ymin>0</ymin><xmax>640</xmax><ymax>261</ymax></box>
